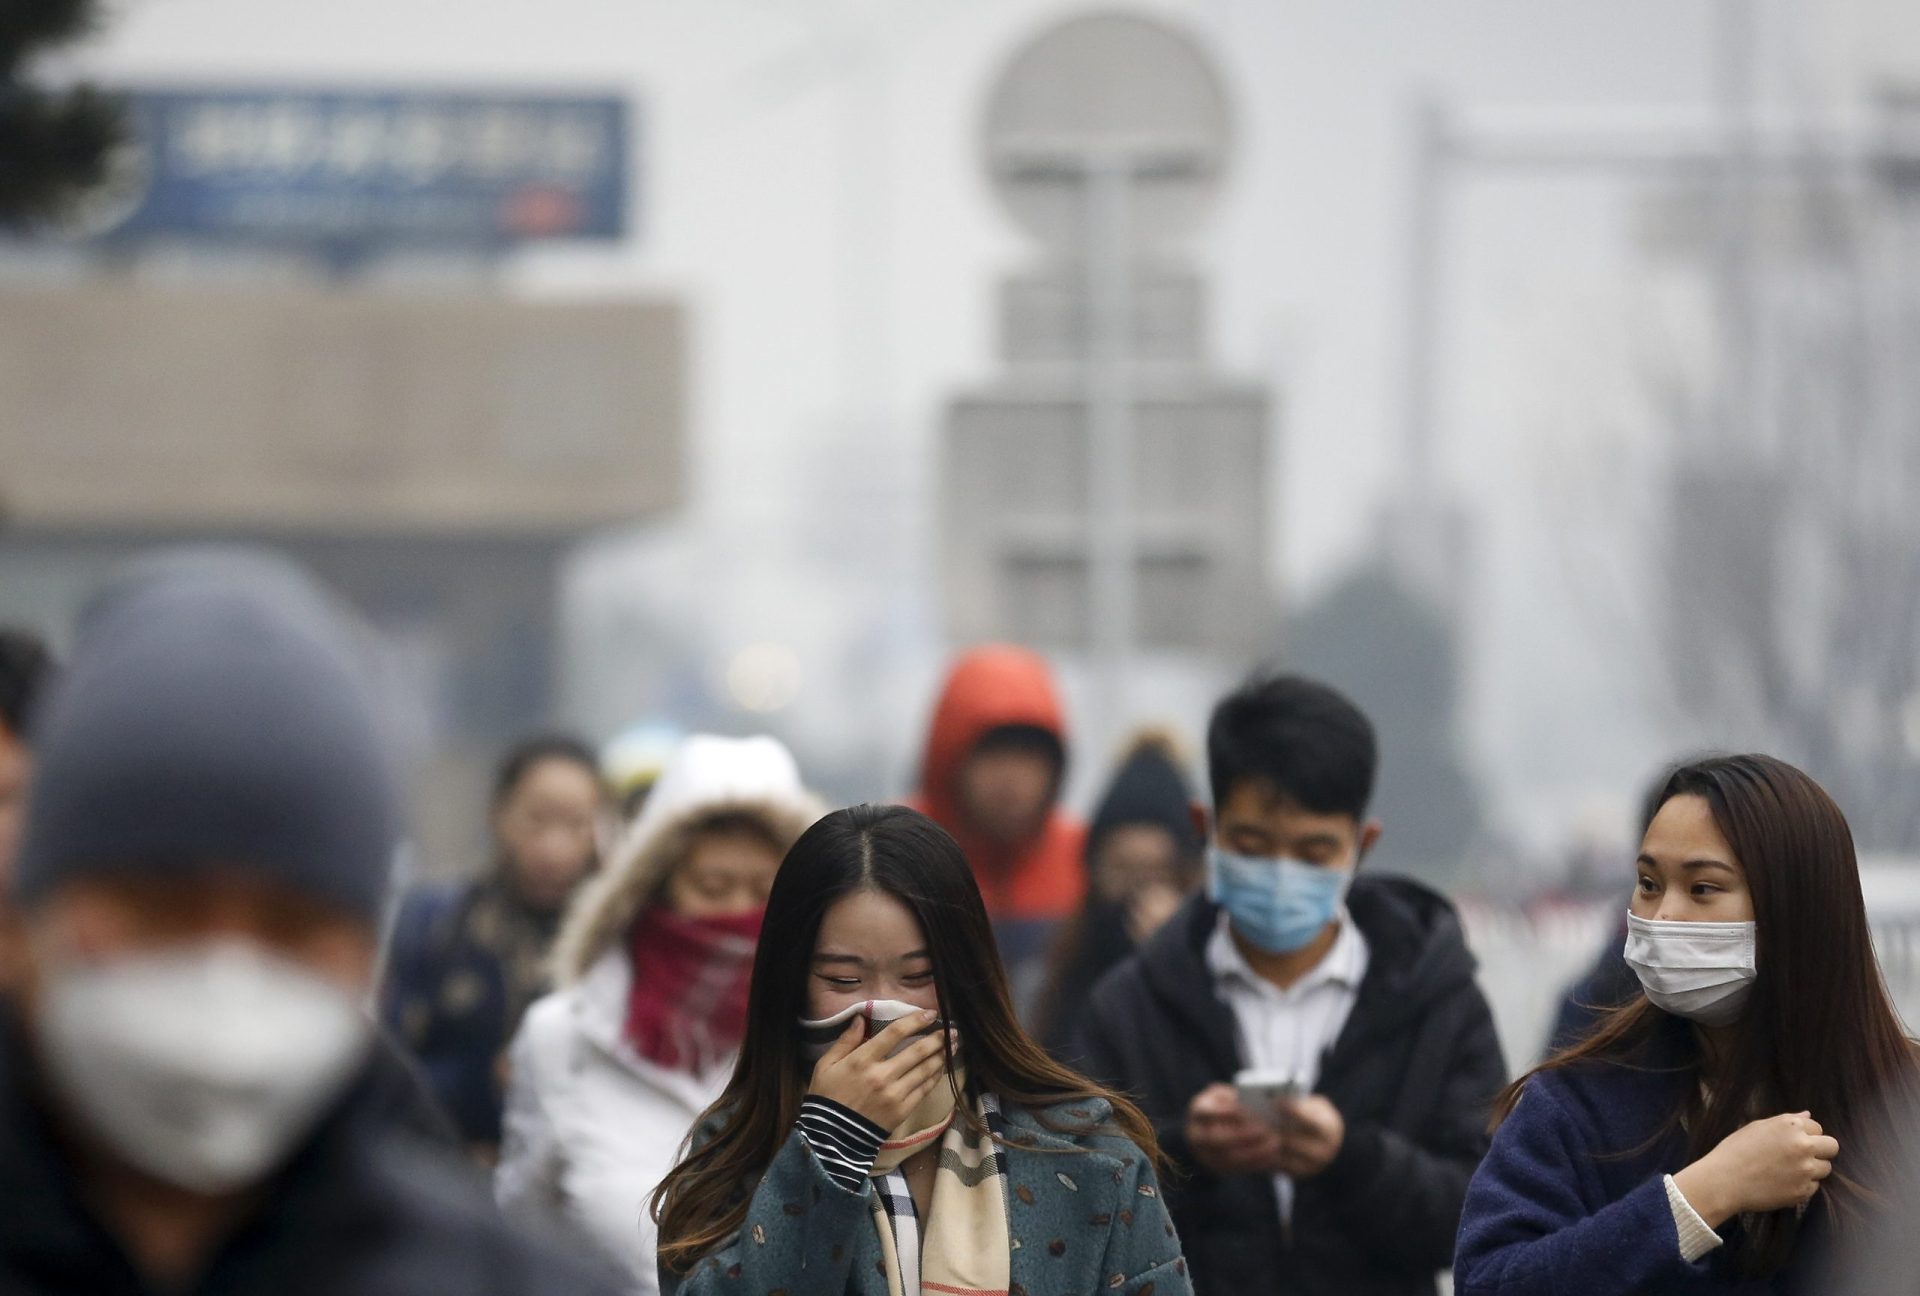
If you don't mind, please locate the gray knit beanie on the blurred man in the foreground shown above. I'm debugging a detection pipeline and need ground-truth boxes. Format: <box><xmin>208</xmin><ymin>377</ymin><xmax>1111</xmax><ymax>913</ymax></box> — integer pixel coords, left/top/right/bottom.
<box><xmin>13</xmin><ymin>551</ymin><xmax>399</xmax><ymax>922</ymax></box>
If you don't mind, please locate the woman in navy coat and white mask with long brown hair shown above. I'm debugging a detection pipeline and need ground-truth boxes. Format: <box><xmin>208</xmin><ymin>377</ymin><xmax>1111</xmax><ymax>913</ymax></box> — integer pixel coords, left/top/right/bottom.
<box><xmin>1453</xmin><ymin>756</ymin><xmax>1916</xmax><ymax>1296</ymax></box>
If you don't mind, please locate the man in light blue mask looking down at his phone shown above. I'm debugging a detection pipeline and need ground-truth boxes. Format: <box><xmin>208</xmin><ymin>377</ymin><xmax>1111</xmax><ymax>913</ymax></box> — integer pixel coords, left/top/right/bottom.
<box><xmin>1081</xmin><ymin>676</ymin><xmax>1507</xmax><ymax>1296</ymax></box>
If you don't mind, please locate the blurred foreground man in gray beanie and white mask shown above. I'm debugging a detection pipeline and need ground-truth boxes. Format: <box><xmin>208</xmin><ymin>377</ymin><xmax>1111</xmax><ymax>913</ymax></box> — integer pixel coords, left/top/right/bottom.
<box><xmin>0</xmin><ymin>557</ymin><xmax>607</xmax><ymax>1296</ymax></box>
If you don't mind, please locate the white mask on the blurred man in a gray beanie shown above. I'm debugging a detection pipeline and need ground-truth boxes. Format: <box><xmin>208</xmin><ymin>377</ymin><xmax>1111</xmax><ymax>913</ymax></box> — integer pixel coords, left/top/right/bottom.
<box><xmin>36</xmin><ymin>941</ymin><xmax>372</xmax><ymax>1192</ymax></box>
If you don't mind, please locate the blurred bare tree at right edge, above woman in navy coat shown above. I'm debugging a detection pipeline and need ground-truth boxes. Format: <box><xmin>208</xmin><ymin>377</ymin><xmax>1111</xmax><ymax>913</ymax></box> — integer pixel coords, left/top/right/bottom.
<box><xmin>1548</xmin><ymin>162</ymin><xmax>1920</xmax><ymax>852</ymax></box>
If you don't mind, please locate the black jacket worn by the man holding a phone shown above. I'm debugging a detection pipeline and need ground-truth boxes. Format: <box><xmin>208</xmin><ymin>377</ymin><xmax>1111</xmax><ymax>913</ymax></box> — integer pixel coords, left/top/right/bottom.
<box><xmin>1083</xmin><ymin>874</ymin><xmax>1507</xmax><ymax>1296</ymax></box>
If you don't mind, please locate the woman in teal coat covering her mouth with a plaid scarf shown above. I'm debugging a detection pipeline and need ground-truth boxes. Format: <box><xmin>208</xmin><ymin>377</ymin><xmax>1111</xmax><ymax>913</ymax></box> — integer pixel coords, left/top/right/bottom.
<box><xmin>653</xmin><ymin>806</ymin><xmax>1190</xmax><ymax>1296</ymax></box>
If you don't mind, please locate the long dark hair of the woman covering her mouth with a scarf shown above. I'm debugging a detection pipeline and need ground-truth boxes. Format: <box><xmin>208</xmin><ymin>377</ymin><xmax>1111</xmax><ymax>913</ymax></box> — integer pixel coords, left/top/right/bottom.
<box><xmin>653</xmin><ymin>804</ymin><xmax>1160</xmax><ymax>1273</ymax></box>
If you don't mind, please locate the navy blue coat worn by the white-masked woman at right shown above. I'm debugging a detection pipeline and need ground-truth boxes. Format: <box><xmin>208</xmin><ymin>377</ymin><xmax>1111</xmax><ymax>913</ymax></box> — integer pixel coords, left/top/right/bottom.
<box><xmin>1453</xmin><ymin>1027</ymin><xmax>1828</xmax><ymax>1296</ymax></box>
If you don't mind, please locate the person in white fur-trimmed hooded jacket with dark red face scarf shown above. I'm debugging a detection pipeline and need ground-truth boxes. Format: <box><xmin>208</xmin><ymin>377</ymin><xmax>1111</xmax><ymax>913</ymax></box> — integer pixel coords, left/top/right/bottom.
<box><xmin>493</xmin><ymin>735</ymin><xmax>824</xmax><ymax>1292</ymax></box>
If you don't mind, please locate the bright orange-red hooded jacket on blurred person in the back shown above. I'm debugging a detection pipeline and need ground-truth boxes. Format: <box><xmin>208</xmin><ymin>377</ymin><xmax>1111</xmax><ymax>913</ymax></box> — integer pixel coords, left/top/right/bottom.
<box><xmin>912</xmin><ymin>645</ymin><xmax>1087</xmax><ymax>920</ymax></box>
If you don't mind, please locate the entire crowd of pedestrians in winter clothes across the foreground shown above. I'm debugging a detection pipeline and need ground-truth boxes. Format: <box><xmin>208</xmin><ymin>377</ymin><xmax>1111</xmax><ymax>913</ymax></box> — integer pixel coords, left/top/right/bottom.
<box><xmin>0</xmin><ymin>551</ymin><xmax>1920</xmax><ymax>1296</ymax></box>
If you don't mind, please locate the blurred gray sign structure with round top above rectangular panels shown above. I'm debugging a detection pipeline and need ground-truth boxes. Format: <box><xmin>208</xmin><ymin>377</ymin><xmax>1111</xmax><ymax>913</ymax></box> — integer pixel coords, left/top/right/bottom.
<box><xmin>939</xmin><ymin>13</ymin><xmax>1273</xmax><ymax>739</ymax></box>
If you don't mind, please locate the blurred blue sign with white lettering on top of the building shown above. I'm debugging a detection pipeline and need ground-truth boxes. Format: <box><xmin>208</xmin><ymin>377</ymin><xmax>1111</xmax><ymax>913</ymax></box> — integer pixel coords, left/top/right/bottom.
<box><xmin>83</xmin><ymin>88</ymin><xmax>630</xmax><ymax>253</ymax></box>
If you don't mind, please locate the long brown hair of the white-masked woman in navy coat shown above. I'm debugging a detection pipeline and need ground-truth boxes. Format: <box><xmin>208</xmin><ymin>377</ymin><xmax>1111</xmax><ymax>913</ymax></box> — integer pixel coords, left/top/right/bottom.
<box><xmin>1496</xmin><ymin>755</ymin><xmax>1920</xmax><ymax>1275</ymax></box>
